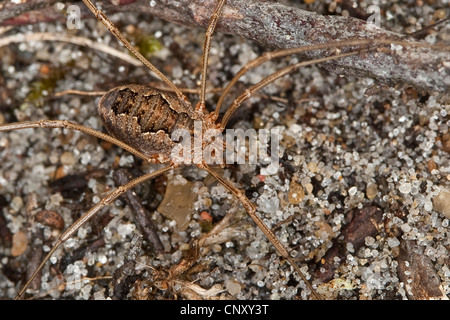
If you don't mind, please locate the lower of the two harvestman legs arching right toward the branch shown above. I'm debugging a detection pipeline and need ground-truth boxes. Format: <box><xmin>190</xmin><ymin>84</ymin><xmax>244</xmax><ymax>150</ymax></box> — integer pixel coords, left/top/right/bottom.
<box><xmin>220</xmin><ymin>51</ymin><xmax>360</xmax><ymax>128</ymax></box>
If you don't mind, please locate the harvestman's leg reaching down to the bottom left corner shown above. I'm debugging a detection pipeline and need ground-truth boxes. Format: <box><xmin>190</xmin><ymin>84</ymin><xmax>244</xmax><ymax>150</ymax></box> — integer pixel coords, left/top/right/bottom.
<box><xmin>15</xmin><ymin>165</ymin><xmax>173</xmax><ymax>300</ymax></box>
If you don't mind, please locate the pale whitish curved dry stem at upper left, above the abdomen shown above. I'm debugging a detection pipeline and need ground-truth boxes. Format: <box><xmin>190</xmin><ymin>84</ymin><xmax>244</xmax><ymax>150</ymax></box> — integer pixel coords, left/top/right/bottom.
<box><xmin>0</xmin><ymin>32</ymin><xmax>141</xmax><ymax>66</ymax></box>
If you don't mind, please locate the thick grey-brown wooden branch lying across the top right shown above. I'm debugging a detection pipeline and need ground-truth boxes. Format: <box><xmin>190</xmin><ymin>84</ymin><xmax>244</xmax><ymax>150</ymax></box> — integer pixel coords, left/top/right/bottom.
<box><xmin>0</xmin><ymin>0</ymin><xmax>450</xmax><ymax>93</ymax></box>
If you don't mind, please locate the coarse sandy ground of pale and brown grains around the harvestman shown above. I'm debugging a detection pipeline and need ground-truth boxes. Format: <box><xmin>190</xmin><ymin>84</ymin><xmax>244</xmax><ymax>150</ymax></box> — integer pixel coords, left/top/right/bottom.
<box><xmin>0</xmin><ymin>1</ymin><xmax>450</xmax><ymax>299</ymax></box>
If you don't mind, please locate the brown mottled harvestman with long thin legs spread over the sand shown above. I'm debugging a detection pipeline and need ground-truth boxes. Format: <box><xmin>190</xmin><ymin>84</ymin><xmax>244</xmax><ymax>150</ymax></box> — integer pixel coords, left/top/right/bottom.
<box><xmin>0</xmin><ymin>0</ymin><xmax>448</xmax><ymax>299</ymax></box>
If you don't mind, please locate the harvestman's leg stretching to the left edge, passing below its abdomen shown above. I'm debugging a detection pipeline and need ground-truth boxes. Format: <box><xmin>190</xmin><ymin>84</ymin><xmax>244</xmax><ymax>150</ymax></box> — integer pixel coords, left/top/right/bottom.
<box><xmin>0</xmin><ymin>120</ymin><xmax>154</xmax><ymax>163</ymax></box>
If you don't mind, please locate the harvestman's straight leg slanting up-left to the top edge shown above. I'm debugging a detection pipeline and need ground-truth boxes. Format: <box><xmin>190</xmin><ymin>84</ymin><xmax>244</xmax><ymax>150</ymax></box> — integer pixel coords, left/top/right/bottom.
<box><xmin>83</xmin><ymin>0</ymin><xmax>187</xmax><ymax>101</ymax></box>
